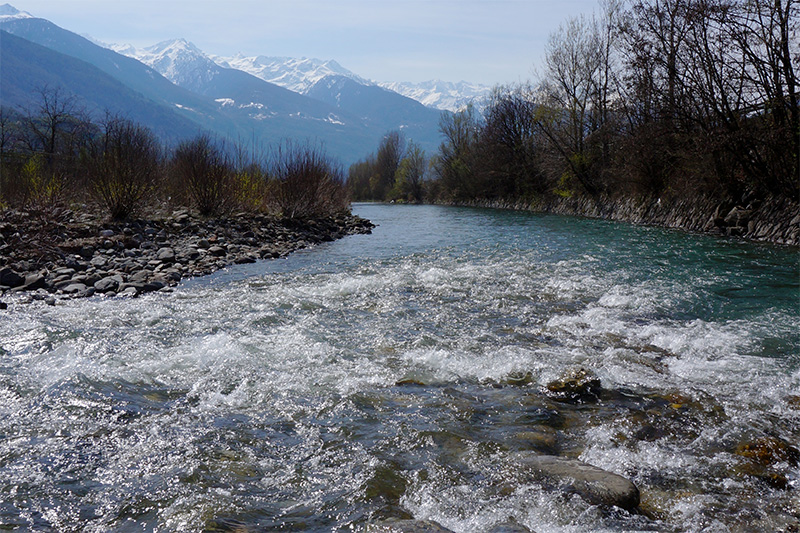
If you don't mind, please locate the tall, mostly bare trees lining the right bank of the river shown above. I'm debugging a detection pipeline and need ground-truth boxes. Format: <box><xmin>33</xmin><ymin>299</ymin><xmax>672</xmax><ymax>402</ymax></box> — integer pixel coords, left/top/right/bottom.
<box><xmin>347</xmin><ymin>0</ymin><xmax>800</xmax><ymax>202</ymax></box>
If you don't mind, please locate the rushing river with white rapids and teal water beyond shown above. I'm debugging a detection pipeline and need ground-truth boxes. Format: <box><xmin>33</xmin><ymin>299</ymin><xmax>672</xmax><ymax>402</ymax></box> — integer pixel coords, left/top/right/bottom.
<box><xmin>0</xmin><ymin>205</ymin><xmax>800</xmax><ymax>533</ymax></box>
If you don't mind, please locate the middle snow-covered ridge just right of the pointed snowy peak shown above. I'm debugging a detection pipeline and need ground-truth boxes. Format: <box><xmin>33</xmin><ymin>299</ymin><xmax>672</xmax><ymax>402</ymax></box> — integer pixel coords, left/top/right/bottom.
<box><xmin>211</xmin><ymin>54</ymin><xmax>373</xmax><ymax>94</ymax></box>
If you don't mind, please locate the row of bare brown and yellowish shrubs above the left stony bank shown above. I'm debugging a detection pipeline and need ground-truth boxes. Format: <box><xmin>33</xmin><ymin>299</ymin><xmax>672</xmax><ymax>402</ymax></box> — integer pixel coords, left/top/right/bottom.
<box><xmin>0</xmin><ymin>88</ymin><xmax>349</xmax><ymax>219</ymax></box>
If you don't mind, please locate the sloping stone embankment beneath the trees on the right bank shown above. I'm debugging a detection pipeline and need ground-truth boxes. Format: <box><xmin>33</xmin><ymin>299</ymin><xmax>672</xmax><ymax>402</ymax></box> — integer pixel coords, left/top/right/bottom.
<box><xmin>444</xmin><ymin>196</ymin><xmax>800</xmax><ymax>246</ymax></box>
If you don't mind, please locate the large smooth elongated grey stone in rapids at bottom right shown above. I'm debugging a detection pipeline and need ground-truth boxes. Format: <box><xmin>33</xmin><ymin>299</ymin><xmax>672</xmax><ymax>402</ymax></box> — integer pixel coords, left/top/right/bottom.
<box><xmin>514</xmin><ymin>452</ymin><xmax>640</xmax><ymax>511</ymax></box>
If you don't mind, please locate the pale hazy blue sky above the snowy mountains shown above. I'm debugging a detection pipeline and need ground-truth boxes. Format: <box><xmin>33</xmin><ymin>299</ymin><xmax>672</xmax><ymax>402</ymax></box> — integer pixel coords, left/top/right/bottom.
<box><xmin>9</xmin><ymin>0</ymin><xmax>597</xmax><ymax>85</ymax></box>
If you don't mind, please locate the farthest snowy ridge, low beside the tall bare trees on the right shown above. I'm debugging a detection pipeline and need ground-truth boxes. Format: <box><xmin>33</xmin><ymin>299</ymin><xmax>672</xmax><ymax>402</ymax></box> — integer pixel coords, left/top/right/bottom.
<box><xmin>378</xmin><ymin>80</ymin><xmax>492</xmax><ymax>111</ymax></box>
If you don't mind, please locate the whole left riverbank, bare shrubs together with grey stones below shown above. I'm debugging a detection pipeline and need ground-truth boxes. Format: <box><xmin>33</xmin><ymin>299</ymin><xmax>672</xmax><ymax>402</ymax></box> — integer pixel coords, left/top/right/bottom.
<box><xmin>0</xmin><ymin>104</ymin><xmax>371</xmax><ymax>306</ymax></box>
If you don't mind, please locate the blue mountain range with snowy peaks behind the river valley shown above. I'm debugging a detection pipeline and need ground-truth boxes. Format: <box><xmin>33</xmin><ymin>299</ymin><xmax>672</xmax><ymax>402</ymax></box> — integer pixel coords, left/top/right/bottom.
<box><xmin>0</xmin><ymin>4</ymin><xmax>488</xmax><ymax>164</ymax></box>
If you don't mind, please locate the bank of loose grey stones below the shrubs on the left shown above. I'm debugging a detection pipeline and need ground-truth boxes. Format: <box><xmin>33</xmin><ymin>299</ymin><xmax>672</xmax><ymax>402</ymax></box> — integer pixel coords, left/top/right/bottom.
<box><xmin>0</xmin><ymin>210</ymin><xmax>374</xmax><ymax>308</ymax></box>
